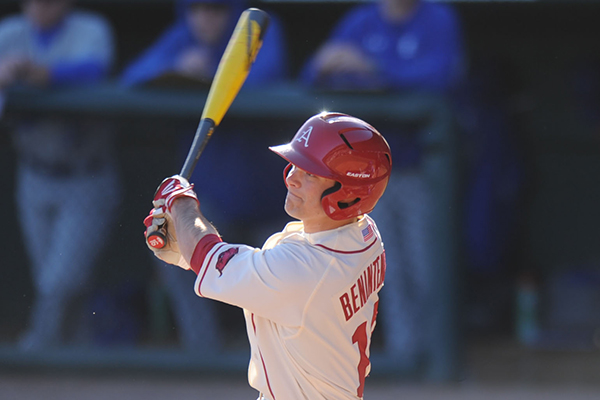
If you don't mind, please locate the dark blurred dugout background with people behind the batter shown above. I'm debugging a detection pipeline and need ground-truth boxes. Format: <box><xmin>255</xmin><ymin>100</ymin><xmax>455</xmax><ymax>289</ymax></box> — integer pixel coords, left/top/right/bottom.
<box><xmin>0</xmin><ymin>0</ymin><xmax>600</xmax><ymax>399</ymax></box>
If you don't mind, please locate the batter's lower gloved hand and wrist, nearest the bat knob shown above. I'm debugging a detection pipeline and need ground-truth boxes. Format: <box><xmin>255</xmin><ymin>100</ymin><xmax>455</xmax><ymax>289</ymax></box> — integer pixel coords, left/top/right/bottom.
<box><xmin>144</xmin><ymin>206</ymin><xmax>190</xmax><ymax>269</ymax></box>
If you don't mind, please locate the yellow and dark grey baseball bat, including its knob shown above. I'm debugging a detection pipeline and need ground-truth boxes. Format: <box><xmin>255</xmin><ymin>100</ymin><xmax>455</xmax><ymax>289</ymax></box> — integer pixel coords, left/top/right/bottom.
<box><xmin>146</xmin><ymin>8</ymin><xmax>269</xmax><ymax>249</ymax></box>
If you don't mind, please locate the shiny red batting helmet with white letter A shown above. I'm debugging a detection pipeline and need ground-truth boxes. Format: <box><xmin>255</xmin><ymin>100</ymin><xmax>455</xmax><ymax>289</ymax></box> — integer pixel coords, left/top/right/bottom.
<box><xmin>269</xmin><ymin>112</ymin><xmax>392</xmax><ymax>220</ymax></box>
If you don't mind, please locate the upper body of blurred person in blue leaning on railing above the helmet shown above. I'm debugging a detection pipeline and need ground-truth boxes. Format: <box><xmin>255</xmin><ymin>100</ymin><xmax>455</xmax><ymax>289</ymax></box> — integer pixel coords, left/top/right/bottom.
<box><xmin>301</xmin><ymin>0</ymin><xmax>464</xmax><ymax>92</ymax></box>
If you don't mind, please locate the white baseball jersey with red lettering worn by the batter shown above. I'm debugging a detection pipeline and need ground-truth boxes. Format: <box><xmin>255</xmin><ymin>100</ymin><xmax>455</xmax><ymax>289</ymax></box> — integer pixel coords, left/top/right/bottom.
<box><xmin>192</xmin><ymin>216</ymin><xmax>385</xmax><ymax>400</ymax></box>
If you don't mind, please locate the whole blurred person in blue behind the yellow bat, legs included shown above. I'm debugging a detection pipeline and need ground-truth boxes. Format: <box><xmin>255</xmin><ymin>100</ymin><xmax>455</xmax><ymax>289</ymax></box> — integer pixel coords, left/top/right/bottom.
<box><xmin>121</xmin><ymin>0</ymin><xmax>288</xmax><ymax>354</ymax></box>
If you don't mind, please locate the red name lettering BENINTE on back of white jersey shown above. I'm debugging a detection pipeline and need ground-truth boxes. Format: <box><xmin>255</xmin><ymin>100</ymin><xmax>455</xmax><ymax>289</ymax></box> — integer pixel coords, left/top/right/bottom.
<box><xmin>340</xmin><ymin>252</ymin><xmax>386</xmax><ymax>321</ymax></box>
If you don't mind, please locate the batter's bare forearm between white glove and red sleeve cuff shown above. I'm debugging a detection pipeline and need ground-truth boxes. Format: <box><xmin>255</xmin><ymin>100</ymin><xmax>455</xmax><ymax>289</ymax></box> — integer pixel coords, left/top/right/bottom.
<box><xmin>171</xmin><ymin>198</ymin><xmax>218</xmax><ymax>264</ymax></box>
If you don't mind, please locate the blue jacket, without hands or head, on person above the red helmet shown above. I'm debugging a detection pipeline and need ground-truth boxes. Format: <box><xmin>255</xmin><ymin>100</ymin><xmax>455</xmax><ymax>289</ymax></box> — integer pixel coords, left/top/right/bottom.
<box><xmin>301</xmin><ymin>1</ymin><xmax>463</xmax><ymax>91</ymax></box>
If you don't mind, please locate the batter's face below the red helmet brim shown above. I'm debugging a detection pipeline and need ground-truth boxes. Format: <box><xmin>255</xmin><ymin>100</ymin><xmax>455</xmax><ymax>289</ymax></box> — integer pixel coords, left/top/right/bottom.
<box><xmin>285</xmin><ymin>166</ymin><xmax>335</xmax><ymax>233</ymax></box>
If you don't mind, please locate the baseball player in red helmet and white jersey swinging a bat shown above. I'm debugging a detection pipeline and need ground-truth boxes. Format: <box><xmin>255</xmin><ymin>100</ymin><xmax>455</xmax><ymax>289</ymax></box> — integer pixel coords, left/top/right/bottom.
<box><xmin>144</xmin><ymin>113</ymin><xmax>392</xmax><ymax>400</ymax></box>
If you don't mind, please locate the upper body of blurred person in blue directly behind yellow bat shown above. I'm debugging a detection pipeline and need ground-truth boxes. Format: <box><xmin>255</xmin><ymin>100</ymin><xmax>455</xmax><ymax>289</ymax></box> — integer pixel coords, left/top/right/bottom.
<box><xmin>121</xmin><ymin>0</ymin><xmax>287</xmax><ymax>86</ymax></box>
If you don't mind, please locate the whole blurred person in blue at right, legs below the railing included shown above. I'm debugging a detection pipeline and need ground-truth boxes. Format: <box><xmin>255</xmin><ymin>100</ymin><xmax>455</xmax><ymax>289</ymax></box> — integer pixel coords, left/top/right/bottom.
<box><xmin>300</xmin><ymin>0</ymin><xmax>465</xmax><ymax>369</ymax></box>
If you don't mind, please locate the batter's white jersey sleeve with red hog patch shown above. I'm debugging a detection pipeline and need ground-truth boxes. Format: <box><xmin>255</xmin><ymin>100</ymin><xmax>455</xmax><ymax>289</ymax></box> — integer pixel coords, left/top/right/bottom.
<box><xmin>195</xmin><ymin>242</ymin><xmax>326</xmax><ymax>326</ymax></box>
